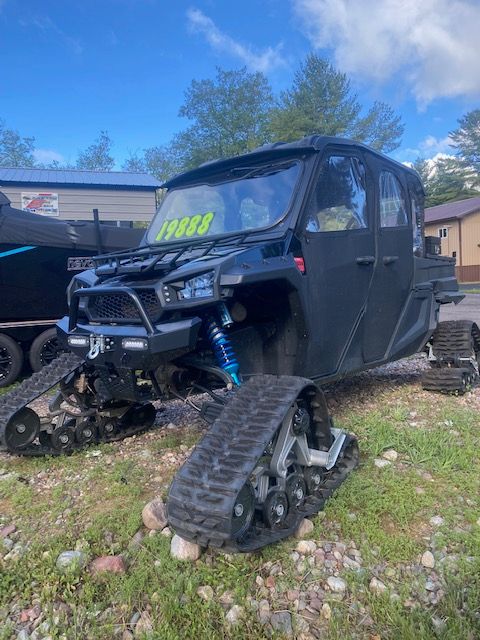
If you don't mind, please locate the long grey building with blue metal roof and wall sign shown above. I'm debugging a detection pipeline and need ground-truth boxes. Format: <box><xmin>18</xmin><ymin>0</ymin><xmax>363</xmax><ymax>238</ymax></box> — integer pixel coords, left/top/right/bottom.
<box><xmin>0</xmin><ymin>167</ymin><xmax>161</xmax><ymax>225</ymax></box>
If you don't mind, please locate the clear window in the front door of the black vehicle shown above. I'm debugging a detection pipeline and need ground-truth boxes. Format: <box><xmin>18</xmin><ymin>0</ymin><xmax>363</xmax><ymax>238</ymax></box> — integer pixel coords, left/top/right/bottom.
<box><xmin>306</xmin><ymin>155</ymin><xmax>368</xmax><ymax>232</ymax></box>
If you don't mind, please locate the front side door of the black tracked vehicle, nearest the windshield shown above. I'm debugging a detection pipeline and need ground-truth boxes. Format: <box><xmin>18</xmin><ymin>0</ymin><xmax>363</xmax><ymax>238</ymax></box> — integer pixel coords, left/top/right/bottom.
<box><xmin>302</xmin><ymin>146</ymin><xmax>375</xmax><ymax>377</ymax></box>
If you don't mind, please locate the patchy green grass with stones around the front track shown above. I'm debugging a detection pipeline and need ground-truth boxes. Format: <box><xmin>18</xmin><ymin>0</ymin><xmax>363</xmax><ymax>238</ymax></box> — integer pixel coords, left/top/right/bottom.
<box><xmin>0</xmin><ymin>384</ymin><xmax>480</xmax><ymax>640</ymax></box>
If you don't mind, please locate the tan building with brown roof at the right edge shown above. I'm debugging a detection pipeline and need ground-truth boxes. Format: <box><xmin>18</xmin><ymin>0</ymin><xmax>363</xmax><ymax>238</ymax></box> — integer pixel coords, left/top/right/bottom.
<box><xmin>425</xmin><ymin>196</ymin><xmax>480</xmax><ymax>282</ymax></box>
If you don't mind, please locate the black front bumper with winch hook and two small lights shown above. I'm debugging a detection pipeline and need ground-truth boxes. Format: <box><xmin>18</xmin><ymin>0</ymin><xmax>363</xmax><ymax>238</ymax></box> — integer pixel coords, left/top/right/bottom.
<box><xmin>57</xmin><ymin>316</ymin><xmax>202</xmax><ymax>370</ymax></box>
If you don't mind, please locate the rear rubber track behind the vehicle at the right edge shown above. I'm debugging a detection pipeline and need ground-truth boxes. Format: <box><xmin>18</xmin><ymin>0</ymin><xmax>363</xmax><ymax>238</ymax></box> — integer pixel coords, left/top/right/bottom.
<box><xmin>422</xmin><ymin>320</ymin><xmax>480</xmax><ymax>394</ymax></box>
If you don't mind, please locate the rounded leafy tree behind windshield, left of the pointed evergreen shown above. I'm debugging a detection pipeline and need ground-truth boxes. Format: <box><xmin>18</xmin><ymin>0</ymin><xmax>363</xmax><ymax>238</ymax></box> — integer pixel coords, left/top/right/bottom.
<box><xmin>169</xmin><ymin>68</ymin><xmax>272</xmax><ymax>168</ymax></box>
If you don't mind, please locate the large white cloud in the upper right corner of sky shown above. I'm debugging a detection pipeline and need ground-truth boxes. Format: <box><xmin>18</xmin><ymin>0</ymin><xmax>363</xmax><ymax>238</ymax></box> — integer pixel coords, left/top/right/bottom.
<box><xmin>294</xmin><ymin>0</ymin><xmax>480</xmax><ymax>107</ymax></box>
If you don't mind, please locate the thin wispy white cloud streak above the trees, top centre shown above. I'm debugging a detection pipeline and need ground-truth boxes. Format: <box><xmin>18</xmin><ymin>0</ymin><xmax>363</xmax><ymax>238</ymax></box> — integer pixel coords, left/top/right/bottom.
<box><xmin>187</xmin><ymin>9</ymin><xmax>286</xmax><ymax>73</ymax></box>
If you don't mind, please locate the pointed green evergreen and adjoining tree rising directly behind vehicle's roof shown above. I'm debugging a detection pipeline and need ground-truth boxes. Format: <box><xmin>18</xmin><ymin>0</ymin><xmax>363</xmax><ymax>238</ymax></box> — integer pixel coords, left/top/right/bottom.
<box><xmin>268</xmin><ymin>54</ymin><xmax>404</xmax><ymax>152</ymax></box>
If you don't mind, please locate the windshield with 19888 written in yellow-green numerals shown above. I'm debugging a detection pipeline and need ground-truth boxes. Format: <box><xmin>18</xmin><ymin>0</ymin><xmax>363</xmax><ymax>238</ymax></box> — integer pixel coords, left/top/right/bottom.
<box><xmin>147</xmin><ymin>161</ymin><xmax>300</xmax><ymax>244</ymax></box>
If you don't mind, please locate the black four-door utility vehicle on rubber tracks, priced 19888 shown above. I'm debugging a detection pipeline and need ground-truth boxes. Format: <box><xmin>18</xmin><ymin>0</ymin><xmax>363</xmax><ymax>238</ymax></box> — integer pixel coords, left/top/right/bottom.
<box><xmin>0</xmin><ymin>136</ymin><xmax>477</xmax><ymax>551</ymax></box>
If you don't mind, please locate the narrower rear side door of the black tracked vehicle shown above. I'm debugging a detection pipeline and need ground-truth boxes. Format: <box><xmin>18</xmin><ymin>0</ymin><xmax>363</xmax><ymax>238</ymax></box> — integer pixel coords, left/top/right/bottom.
<box><xmin>363</xmin><ymin>161</ymin><xmax>413</xmax><ymax>363</ymax></box>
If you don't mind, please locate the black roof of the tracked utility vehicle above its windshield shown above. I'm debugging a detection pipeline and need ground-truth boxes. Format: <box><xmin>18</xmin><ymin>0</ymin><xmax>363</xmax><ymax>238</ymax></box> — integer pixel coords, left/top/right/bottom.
<box><xmin>163</xmin><ymin>135</ymin><xmax>419</xmax><ymax>188</ymax></box>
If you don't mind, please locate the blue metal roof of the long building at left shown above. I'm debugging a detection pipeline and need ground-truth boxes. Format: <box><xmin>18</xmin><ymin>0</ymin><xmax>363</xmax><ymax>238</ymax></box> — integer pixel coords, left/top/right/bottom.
<box><xmin>0</xmin><ymin>167</ymin><xmax>161</xmax><ymax>189</ymax></box>
